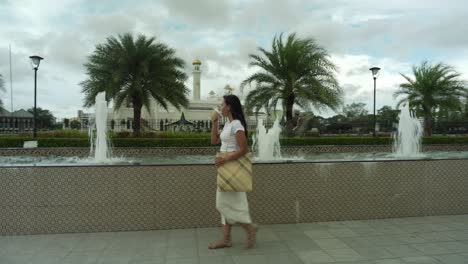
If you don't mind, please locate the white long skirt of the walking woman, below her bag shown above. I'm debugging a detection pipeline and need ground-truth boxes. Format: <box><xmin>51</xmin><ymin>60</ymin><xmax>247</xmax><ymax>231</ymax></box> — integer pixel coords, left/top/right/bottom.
<box><xmin>216</xmin><ymin>190</ymin><xmax>252</xmax><ymax>225</ymax></box>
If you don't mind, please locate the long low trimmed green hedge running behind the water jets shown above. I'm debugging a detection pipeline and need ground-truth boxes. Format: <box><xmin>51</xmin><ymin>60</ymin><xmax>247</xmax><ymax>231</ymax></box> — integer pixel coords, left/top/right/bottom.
<box><xmin>0</xmin><ymin>136</ymin><xmax>468</xmax><ymax>148</ymax></box>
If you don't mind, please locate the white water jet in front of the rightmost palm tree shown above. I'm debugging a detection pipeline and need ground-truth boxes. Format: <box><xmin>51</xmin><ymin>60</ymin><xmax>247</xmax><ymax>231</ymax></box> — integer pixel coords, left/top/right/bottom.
<box><xmin>393</xmin><ymin>103</ymin><xmax>423</xmax><ymax>158</ymax></box>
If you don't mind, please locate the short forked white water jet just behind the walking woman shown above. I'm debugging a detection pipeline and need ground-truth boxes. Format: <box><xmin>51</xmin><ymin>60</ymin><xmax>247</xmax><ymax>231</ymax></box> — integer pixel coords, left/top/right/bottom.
<box><xmin>252</xmin><ymin>118</ymin><xmax>281</xmax><ymax>161</ymax></box>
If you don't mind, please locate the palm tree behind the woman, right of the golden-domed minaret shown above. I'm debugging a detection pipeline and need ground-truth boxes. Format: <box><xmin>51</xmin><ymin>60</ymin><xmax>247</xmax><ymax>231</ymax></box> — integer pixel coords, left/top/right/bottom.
<box><xmin>241</xmin><ymin>33</ymin><xmax>342</xmax><ymax>130</ymax></box>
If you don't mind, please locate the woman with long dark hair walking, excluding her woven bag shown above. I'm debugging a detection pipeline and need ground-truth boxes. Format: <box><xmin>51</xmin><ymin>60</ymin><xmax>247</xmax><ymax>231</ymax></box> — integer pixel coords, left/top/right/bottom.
<box><xmin>208</xmin><ymin>95</ymin><xmax>257</xmax><ymax>249</ymax></box>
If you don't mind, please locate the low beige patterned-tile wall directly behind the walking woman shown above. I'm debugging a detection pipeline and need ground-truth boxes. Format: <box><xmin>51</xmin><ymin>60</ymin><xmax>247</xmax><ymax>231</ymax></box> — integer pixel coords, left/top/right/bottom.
<box><xmin>0</xmin><ymin>160</ymin><xmax>468</xmax><ymax>235</ymax></box>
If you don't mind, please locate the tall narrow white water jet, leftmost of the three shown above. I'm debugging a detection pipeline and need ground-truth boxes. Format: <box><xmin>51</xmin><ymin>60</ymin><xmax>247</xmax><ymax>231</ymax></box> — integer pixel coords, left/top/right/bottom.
<box><xmin>89</xmin><ymin>92</ymin><xmax>112</xmax><ymax>163</ymax></box>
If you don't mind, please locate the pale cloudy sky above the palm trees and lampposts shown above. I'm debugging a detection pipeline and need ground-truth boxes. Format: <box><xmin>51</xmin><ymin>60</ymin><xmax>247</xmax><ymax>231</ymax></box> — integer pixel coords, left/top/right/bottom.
<box><xmin>0</xmin><ymin>0</ymin><xmax>468</xmax><ymax>118</ymax></box>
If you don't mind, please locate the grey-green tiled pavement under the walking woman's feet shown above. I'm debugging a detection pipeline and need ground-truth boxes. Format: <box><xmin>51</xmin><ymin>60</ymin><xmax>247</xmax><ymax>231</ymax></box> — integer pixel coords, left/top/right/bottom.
<box><xmin>0</xmin><ymin>215</ymin><xmax>468</xmax><ymax>264</ymax></box>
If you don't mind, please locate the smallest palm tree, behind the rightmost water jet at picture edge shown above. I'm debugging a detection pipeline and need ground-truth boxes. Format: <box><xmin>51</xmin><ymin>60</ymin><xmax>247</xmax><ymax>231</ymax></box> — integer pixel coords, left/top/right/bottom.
<box><xmin>393</xmin><ymin>61</ymin><xmax>468</xmax><ymax>136</ymax></box>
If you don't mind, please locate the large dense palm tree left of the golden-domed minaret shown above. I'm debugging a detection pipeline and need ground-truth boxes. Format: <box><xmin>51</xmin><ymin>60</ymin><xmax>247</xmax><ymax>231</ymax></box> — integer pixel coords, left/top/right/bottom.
<box><xmin>81</xmin><ymin>33</ymin><xmax>189</xmax><ymax>135</ymax></box>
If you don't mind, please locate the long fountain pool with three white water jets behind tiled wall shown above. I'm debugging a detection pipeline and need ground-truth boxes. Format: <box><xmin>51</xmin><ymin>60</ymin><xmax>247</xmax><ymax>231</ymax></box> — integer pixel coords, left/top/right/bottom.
<box><xmin>0</xmin><ymin>100</ymin><xmax>468</xmax><ymax>166</ymax></box>
